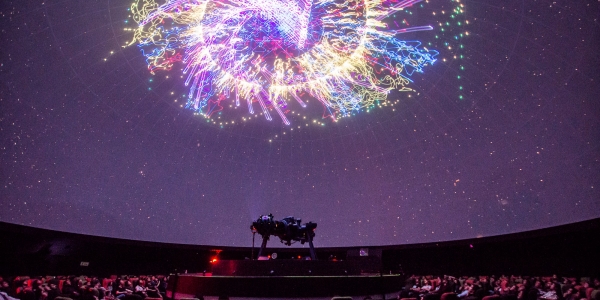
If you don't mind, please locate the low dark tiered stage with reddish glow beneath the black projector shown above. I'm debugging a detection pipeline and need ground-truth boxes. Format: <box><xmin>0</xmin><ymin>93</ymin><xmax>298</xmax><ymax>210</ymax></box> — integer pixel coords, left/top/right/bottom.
<box><xmin>167</xmin><ymin>260</ymin><xmax>404</xmax><ymax>299</ymax></box>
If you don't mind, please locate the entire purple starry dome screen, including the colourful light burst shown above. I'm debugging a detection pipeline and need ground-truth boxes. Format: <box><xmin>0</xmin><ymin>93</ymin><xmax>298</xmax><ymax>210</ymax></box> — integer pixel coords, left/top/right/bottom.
<box><xmin>0</xmin><ymin>0</ymin><xmax>600</xmax><ymax>247</ymax></box>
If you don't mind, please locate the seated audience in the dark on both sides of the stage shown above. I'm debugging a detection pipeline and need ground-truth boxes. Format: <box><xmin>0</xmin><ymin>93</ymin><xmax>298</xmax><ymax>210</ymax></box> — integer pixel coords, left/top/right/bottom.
<box><xmin>0</xmin><ymin>275</ymin><xmax>600</xmax><ymax>300</ymax></box>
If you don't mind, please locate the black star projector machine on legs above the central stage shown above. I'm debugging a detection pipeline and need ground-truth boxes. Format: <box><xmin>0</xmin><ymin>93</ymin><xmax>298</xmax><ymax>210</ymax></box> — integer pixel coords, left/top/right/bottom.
<box><xmin>250</xmin><ymin>214</ymin><xmax>317</xmax><ymax>260</ymax></box>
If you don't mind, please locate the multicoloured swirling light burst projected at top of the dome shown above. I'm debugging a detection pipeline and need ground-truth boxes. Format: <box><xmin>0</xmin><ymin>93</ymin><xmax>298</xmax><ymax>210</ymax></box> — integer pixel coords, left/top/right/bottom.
<box><xmin>131</xmin><ymin>0</ymin><xmax>438</xmax><ymax>125</ymax></box>
